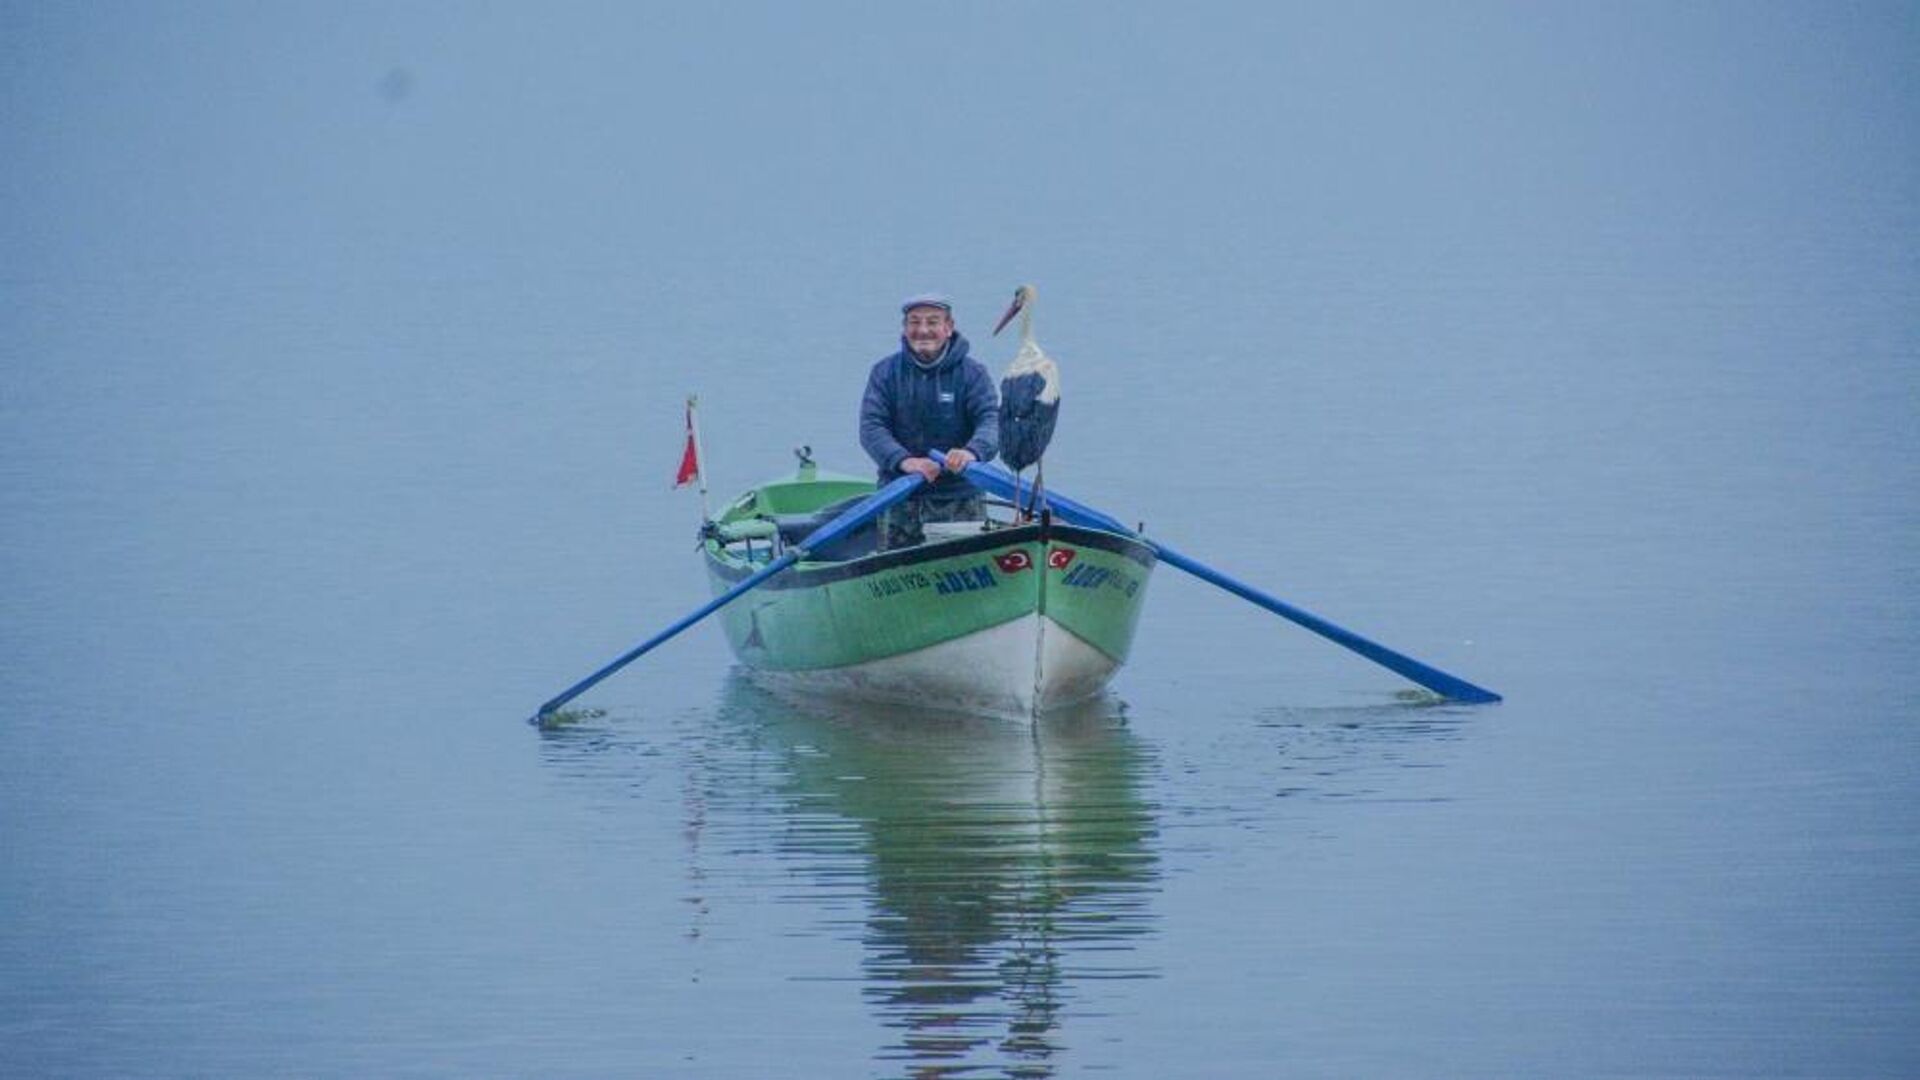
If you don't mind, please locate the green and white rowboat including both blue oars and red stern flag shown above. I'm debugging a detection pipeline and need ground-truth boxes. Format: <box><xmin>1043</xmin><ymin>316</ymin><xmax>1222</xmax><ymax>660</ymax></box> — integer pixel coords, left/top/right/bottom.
<box><xmin>528</xmin><ymin>428</ymin><xmax>1501</xmax><ymax>726</ymax></box>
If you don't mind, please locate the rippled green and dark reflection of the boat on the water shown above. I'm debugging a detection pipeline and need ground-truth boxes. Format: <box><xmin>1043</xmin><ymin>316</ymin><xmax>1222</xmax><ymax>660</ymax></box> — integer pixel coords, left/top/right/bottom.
<box><xmin>730</xmin><ymin>684</ymin><xmax>1158</xmax><ymax>1076</ymax></box>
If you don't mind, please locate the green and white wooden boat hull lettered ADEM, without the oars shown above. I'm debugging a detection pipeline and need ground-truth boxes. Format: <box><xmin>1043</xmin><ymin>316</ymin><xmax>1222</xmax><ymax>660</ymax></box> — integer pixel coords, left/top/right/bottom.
<box><xmin>701</xmin><ymin>453</ymin><xmax>1156</xmax><ymax>719</ymax></box>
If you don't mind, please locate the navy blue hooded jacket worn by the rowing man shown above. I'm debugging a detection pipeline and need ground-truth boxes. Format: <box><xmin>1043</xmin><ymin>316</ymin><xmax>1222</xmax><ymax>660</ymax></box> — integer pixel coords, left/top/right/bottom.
<box><xmin>860</xmin><ymin>331</ymin><xmax>1000</xmax><ymax>500</ymax></box>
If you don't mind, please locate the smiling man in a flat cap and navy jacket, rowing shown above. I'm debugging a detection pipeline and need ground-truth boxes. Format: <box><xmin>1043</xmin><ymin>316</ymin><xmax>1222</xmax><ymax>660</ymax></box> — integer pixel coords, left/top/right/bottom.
<box><xmin>860</xmin><ymin>294</ymin><xmax>1000</xmax><ymax>552</ymax></box>
